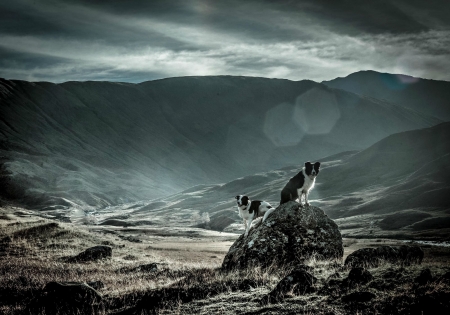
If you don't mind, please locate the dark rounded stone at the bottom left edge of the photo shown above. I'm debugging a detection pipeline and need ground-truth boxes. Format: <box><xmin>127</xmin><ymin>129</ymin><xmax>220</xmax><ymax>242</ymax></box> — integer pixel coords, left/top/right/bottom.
<box><xmin>26</xmin><ymin>282</ymin><xmax>105</xmax><ymax>314</ymax></box>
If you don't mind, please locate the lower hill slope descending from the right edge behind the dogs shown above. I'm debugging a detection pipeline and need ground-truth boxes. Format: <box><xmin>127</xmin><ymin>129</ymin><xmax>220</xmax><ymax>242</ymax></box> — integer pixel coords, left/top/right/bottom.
<box><xmin>127</xmin><ymin>123</ymin><xmax>450</xmax><ymax>237</ymax></box>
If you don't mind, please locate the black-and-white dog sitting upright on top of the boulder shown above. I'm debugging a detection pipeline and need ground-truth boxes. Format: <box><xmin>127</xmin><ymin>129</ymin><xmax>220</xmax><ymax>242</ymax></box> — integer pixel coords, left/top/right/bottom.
<box><xmin>280</xmin><ymin>162</ymin><xmax>320</xmax><ymax>206</ymax></box>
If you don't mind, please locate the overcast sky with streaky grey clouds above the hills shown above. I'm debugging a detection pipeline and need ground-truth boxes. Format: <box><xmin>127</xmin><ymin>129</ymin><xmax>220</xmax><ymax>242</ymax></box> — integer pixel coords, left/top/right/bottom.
<box><xmin>0</xmin><ymin>0</ymin><xmax>450</xmax><ymax>82</ymax></box>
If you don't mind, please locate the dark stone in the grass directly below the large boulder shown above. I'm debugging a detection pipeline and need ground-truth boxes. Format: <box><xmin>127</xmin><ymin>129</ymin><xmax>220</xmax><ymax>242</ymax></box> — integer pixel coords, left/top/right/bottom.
<box><xmin>260</xmin><ymin>268</ymin><xmax>317</xmax><ymax>304</ymax></box>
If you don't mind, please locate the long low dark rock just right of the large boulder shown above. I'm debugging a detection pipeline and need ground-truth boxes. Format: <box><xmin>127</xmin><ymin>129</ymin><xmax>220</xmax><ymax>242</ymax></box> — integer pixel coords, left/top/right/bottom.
<box><xmin>344</xmin><ymin>245</ymin><xmax>424</xmax><ymax>268</ymax></box>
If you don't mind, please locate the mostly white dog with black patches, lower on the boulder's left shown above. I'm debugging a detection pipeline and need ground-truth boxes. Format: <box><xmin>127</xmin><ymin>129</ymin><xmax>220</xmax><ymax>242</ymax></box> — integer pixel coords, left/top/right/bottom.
<box><xmin>235</xmin><ymin>195</ymin><xmax>275</xmax><ymax>237</ymax></box>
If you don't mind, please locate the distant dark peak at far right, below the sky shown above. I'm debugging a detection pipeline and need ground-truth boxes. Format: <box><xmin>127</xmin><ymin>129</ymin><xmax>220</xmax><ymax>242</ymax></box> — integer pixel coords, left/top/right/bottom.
<box><xmin>322</xmin><ymin>71</ymin><xmax>450</xmax><ymax>121</ymax></box>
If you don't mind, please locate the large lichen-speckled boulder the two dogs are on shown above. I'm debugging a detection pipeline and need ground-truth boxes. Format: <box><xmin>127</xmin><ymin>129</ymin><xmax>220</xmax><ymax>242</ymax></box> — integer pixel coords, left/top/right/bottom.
<box><xmin>222</xmin><ymin>201</ymin><xmax>344</xmax><ymax>270</ymax></box>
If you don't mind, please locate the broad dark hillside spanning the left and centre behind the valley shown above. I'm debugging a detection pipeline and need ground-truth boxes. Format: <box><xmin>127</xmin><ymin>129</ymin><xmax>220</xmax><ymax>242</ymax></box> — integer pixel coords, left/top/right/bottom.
<box><xmin>0</xmin><ymin>76</ymin><xmax>439</xmax><ymax>210</ymax></box>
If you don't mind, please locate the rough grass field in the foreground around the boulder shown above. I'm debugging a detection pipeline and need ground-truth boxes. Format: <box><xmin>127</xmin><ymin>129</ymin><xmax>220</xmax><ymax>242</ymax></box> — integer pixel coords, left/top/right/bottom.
<box><xmin>0</xmin><ymin>207</ymin><xmax>450</xmax><ymax>315</ymax></box>
